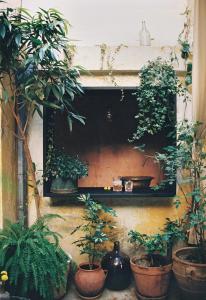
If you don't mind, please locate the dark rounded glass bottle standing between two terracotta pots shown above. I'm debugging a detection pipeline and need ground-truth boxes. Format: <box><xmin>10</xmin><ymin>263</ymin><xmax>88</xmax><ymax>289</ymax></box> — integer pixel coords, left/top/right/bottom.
<box><xmin>102</xmin><ymin>241</ymin><xmax>131</xmax><ymax>291</ymax></box>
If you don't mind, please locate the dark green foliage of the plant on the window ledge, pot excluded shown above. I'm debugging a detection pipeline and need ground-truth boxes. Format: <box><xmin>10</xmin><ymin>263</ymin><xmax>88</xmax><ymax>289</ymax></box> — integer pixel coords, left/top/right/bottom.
<box><xmin>44</xmin><ymin>144</ymin><xmax>88</xmax><ymax>180</ymax></box>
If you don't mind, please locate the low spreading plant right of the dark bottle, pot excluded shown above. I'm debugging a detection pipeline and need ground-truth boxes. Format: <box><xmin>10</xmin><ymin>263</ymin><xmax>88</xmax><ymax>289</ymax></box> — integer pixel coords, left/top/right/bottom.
<box><xmin>128</xmin><ymin>219</ymin><xmax>185</xmax><ymax>267</ymax></box>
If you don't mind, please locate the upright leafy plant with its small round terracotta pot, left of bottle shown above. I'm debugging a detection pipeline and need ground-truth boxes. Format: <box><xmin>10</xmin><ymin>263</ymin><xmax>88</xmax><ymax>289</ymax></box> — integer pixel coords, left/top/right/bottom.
<box><xmin>72</xmin><ymin>194</ymin><xmax>116</xmax><ymax>299</ymax></box>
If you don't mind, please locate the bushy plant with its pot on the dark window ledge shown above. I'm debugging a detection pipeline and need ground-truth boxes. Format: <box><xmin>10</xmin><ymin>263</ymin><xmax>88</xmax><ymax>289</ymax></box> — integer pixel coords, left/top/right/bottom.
<box><xmin>44</xmin><ymin>145</ymin><xmax>88</xmax><ymax>194</ymax></box>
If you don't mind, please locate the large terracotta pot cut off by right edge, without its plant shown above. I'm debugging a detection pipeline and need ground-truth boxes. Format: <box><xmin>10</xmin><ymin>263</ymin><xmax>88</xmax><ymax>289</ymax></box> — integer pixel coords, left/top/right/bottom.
<box><xmin>173</xmin><ymin>247</ymin><xmax>206</xmax><ymax>300</ymax></box>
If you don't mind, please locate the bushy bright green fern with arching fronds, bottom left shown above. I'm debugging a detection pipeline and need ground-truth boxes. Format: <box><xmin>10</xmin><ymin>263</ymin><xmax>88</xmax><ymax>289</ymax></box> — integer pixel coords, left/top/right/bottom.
<box><xmin>0</xmin><ymin>215</ymin><xmax>68</xmax><ymax>300</ymax></box>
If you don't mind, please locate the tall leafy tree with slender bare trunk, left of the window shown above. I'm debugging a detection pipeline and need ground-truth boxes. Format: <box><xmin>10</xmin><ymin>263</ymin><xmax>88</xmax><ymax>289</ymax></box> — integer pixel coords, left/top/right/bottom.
<box><xmin>0</xmin><ymin>8</ymin><xmax>84</xmax><ymax>216</ymax></box>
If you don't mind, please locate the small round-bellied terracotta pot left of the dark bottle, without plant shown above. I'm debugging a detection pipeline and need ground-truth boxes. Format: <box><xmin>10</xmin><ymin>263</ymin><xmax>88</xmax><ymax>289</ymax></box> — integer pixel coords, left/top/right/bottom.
<box><xmin>74</xmin><ymin>263</ymin><xmax>107</xmax><ymax>299</ymax></box>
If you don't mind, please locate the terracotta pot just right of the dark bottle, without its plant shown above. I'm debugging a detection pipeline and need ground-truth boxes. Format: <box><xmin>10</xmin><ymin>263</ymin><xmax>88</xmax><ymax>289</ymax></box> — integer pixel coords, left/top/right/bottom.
<box><xmin>130</xmin><ymin>257</ymin><xmax>172</xmax><ymax>298</ymax></box>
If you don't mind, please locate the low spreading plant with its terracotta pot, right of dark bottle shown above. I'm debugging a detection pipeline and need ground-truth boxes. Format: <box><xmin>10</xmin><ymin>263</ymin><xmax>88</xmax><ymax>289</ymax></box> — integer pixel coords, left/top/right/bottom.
<box><xmin>128</xmin><ymin>219</ymin><xmax>183</xmax><ymax>299</ymax></box>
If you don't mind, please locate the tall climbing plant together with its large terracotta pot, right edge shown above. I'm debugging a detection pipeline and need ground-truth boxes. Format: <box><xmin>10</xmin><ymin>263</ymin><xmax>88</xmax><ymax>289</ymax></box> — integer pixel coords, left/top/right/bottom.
<box><xmin>156</xmin><ymin>120</ymin><xmax>206</xmax><ymax>299</ymax></box>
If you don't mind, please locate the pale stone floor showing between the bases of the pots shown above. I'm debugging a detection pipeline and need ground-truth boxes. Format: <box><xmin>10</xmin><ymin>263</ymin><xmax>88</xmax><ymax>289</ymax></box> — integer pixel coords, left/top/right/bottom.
<box><xmin>63</xmin><ymin>282</ymin><xmax>180</xmax><ymax>300</ymax></box>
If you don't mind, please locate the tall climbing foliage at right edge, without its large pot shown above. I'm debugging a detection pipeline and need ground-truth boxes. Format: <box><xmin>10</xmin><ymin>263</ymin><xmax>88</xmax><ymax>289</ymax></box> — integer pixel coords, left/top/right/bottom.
<box><xmin>156</xmin><ymin>120</ymin><xmax>206</xmax><ymax>263</ymax></box>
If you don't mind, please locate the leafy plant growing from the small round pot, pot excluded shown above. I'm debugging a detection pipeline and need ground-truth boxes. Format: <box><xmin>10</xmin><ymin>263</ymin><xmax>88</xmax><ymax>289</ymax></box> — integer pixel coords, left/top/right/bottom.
<box><xmin>72</xmin><ymin>194</ymin><xmax>116</xmax><ymax>270</ymax></box>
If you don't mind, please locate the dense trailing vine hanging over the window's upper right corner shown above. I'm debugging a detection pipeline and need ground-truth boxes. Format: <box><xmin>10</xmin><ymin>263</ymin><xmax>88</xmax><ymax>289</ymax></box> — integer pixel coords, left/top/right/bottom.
<box><xmin>131</xmin><ymin>58</ymin><xmax>183</xmax><ymax>142</ymax></box>
